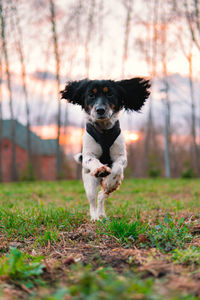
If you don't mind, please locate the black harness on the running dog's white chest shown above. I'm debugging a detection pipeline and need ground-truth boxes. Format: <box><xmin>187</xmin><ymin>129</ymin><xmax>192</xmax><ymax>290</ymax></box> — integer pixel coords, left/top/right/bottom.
<box><xmin>86</xmin><ymin>121</ymin><xmax>121</xmax><ymax>167</ymax></box>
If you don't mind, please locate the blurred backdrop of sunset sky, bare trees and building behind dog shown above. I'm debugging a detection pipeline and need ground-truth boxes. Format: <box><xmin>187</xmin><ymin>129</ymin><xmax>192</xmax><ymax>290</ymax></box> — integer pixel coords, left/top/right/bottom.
<box><xmin>0</xmin><ymin>0</ymin><xmax>200</xmax><ymax>181</ymax></box>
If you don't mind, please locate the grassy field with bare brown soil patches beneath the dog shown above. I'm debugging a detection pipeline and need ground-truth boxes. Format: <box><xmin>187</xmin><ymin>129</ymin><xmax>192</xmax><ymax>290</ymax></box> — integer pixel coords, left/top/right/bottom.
<box><xmin>0</xmin><ymin>179</ymin><xmax>200</xmax><ymax>300</ymax></box>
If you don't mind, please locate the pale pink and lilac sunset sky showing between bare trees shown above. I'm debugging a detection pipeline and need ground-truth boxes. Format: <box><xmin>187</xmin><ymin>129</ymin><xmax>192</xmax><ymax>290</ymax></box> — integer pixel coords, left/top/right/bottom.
<box><xmin>2</xmin><ymin>0</ymin><xmax>200</xmax><ymax>142</ymax></box>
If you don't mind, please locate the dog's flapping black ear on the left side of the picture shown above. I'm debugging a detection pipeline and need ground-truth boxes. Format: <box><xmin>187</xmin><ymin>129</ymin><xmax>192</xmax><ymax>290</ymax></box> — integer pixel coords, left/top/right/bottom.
<box><xmin>60</xmin><ymin>79</ymin><xmax>89</xmax><ymax>107</ymax></box>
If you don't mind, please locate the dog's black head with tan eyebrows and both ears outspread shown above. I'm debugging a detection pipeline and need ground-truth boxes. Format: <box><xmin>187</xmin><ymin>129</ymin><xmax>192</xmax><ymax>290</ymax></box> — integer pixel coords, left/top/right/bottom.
<box><xmin>61</xmin><ymin>78</ymin><xmax>150</xmax><ymax>122</ymax></box>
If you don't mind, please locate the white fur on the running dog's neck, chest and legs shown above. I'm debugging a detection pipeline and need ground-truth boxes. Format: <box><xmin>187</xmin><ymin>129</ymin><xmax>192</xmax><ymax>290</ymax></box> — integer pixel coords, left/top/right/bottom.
<box><xmin>76</xmin><ymin>114</ymin><xmax>127</xmax><ymax>220</ymax></box>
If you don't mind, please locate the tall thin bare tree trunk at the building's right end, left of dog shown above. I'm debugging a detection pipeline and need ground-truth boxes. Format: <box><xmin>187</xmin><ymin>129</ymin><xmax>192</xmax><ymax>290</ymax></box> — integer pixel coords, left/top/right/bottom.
<box><xmin>49</xmin><ymin>0</ymin><xmax>61</xmax><ymax>178</ymax></box>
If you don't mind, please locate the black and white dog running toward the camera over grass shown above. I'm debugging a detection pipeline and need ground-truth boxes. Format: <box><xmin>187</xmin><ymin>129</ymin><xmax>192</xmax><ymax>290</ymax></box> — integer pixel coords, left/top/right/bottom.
<box><xmin>61</xmin><ymin>78</ymin><xmax>150</xmax><ymax>220</ymax></box>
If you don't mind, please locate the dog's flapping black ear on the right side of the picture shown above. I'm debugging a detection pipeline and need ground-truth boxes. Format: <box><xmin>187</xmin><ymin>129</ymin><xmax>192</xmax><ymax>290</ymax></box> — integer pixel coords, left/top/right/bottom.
<box><xmin>116</xmin><ymin>77</ymin><xmax>151</xmax><ymax>111</ymax></box>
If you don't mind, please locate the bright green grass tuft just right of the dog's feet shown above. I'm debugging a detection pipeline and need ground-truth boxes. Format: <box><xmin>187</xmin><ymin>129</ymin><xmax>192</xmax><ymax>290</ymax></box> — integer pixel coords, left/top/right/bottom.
<box><xmin>101</xmin><ymin>214</ymin><xmax>148</xmax><ymax>244</ymax></box>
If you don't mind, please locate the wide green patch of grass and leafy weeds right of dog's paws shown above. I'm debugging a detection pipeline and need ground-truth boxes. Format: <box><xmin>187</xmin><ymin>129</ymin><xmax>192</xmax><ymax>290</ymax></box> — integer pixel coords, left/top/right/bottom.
<box><xmin>97</xmin><ymin>213</ymin><xmax>192</xmax><ymax>252</ymax></box>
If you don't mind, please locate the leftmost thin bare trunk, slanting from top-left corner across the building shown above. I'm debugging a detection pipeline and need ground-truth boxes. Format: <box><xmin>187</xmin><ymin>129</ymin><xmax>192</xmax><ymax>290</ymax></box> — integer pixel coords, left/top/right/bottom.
<box><xmin>0</xmin><ymin>0</ymin><xmax>18</xmax><ymax>181</ymax></box>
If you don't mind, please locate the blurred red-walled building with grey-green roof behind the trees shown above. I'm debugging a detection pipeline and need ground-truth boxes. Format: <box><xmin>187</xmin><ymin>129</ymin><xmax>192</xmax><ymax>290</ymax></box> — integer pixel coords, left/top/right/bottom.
<box><xmin>0</xmin><ymin>120</ymin><xmax>60</xmax><ymax>182</ymax></box>
